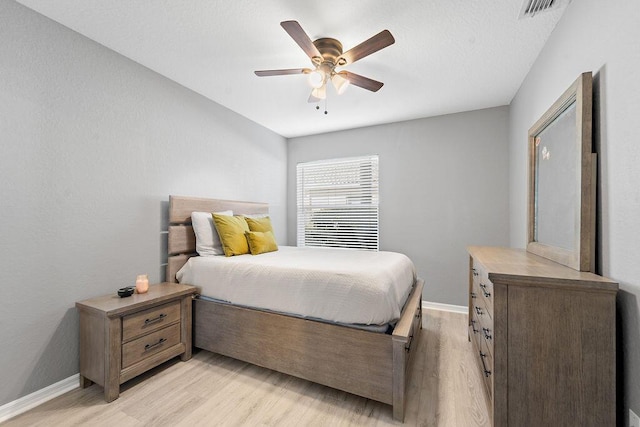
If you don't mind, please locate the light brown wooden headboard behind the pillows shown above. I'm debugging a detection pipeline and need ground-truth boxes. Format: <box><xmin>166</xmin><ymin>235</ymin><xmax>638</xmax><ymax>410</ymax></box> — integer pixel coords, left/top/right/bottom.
<box><xmin>166</xmin><ymin>196</ymin><xmax>269</xmax><ymax>283</ymax></box>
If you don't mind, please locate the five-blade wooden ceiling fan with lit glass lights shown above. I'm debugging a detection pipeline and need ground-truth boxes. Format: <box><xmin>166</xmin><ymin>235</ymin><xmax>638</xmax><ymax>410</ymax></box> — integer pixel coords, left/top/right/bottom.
<box><xmin>255</xmin><ymin>21</ymin><xmax>395</xmax><ymax>102</ymax></box>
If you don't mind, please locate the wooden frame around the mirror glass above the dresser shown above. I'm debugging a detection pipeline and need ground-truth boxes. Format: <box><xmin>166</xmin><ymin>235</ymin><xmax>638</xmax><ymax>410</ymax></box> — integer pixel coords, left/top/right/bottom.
<box><xmin>527</xmin><ymin>72</ymin><xmax>596</xmax><ymax>272</ymax></box>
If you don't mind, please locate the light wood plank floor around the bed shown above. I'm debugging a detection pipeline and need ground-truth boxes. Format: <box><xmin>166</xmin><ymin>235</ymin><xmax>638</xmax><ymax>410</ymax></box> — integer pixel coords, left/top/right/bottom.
<box><xmin>3</xmin><ymin>310</ymin><xmax>489</xmax><ymax>427</ymax></box>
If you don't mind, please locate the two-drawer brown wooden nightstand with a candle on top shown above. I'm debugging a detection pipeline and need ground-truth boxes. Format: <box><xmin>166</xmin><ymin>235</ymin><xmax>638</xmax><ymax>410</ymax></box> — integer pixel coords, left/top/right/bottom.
<box><xmin>76</xmin><ymin>283</ymin><xmax>196</xmax><ymax>402</ymax></box>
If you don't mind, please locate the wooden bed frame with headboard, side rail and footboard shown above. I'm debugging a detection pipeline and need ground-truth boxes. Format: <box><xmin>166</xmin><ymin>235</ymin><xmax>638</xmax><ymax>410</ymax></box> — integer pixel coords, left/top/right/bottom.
<box><xmin>167</xmin><ymin>196</ymin><xmax>424</xmax><ymax>421</ymax></box>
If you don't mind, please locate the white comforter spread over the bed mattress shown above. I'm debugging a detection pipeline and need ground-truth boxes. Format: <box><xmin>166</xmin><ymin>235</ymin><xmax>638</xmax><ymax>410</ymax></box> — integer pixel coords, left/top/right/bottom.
<box><xmin>177</xmin><ymin>246</ymin><xmax>415</xmax><ymax>325</ymax></box>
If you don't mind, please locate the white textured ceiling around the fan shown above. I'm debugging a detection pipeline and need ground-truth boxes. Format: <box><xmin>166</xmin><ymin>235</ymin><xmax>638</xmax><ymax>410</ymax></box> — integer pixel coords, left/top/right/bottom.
<box><xmin>18</xmin><ymin>0</ymin><xmax>564</xmax><ymax>138</ymax></box>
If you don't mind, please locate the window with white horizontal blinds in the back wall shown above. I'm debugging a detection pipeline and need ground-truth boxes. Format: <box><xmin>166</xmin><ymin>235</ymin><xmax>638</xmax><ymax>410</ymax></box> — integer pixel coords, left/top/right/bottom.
<box><xmin>297</xmin><ymin>156</ymin><xmax>378</xmax><ymax>251</ymax></box>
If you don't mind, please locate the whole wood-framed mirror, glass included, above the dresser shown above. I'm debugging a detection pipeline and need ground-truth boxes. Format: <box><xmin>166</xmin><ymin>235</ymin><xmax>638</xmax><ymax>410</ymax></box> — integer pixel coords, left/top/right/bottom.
<box><xmin>527</xmin><ymin>72</ymin><xmax>596</xmax><ymax>271</ymax></box>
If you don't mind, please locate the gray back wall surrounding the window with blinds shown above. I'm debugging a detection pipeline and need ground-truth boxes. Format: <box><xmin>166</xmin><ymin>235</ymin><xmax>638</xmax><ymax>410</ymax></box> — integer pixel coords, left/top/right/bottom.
<box><xmin>287</xmin><ymin>107</ymin><xmax>509</xmax><ymax>306</ymax></box>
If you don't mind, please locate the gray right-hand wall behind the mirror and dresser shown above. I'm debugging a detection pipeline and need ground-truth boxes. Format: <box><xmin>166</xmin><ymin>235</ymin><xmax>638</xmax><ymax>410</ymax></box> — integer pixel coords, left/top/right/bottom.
<box><xmin>509</xmin><ymin>0</ymin><xmax>640</xmax><ymax>425</ymax></box>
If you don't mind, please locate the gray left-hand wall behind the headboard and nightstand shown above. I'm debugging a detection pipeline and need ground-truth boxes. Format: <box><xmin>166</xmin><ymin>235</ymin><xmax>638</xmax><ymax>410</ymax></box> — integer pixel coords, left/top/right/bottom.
<box><xmin>0</xmin><ymin>0</ymin><xmax>287</xmax><ymax>405</ymax></box>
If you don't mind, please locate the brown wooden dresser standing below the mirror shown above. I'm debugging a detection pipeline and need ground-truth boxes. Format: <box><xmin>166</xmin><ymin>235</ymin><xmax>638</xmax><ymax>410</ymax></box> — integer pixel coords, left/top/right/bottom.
<box><xmin>468</xmin><ymin>246</ymin><xmax>618</xmax><ymax>427</ymax></box>
